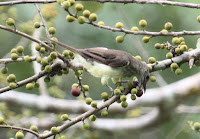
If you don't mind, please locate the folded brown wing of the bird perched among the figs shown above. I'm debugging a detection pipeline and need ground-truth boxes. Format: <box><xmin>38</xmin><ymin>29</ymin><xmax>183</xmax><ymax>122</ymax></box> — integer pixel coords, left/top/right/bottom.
<box><xmin>79</xmin><ymin>48</ymin><xmax>132</xmax><ymax>67</ymax></box>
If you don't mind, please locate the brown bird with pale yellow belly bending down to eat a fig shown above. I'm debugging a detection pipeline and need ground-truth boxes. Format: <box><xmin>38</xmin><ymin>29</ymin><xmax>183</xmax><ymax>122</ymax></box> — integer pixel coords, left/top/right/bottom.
<box><xmin>49</xmin><ymin>40</ymin><xmax>150</xmax><ymax>92</ymax></box>
